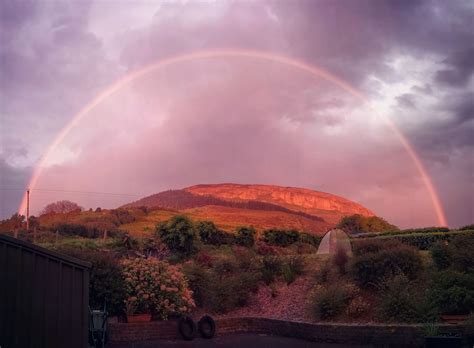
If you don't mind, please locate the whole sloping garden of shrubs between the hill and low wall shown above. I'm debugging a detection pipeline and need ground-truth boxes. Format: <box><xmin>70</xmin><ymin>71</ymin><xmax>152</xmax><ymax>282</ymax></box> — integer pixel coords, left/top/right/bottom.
<box><xmin>0</xmin><ymin>212</ymin><xmax>474</xmax><ymax>330</ymax></box>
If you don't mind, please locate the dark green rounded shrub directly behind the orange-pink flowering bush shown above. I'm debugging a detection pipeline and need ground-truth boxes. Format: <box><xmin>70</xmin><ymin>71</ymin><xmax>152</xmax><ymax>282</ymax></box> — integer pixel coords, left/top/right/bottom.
<box><xmin>156</xmin><ymin>215</ymin><xmax>195</xmax><ymax>255</ymax></box>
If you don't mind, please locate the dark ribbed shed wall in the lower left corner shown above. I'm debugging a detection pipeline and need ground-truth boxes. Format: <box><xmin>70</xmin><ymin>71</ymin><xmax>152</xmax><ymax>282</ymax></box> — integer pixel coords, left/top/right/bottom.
<box><xmin>0</xmin><ymin>235</ymin><xmax>90</xmax><ymax>348</ymax></box>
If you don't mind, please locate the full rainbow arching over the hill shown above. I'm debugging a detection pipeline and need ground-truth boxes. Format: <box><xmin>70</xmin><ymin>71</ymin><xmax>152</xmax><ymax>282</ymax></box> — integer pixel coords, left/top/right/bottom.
<box><xmin>18</xmin><ymin>49</ymin><xmax>447</xmax><ymax>226</ymax></box>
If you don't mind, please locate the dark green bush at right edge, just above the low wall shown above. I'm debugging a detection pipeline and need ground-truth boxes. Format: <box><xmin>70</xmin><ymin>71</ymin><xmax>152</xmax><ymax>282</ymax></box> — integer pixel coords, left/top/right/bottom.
<box><xmin>429</xmin><ymin>270</ymin><xmax>474</xmax><ymax>314</ymax></box>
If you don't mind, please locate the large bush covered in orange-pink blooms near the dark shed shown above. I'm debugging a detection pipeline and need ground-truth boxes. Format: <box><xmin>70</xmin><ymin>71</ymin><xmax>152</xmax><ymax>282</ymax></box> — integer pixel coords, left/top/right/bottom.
<box><xmin>123</xmin><ymin>258</ymin><xmax>195</xmax><ymax>319</ymax></box>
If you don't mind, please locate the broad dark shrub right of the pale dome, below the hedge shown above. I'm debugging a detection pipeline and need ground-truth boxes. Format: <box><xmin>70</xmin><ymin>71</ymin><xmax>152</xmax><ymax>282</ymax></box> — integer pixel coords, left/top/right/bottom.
<box><xmin>350</xmin><ymin>242</ymin><xmax>422</xmax><ymax>287</ymax></box>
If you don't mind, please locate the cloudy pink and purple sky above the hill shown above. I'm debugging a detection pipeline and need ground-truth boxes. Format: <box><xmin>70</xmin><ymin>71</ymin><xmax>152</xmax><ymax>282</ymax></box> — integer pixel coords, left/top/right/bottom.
<box><xmin>0</xmin><ymin>0</ymin><xmax>474</xmax><ymax>227</ymax></box>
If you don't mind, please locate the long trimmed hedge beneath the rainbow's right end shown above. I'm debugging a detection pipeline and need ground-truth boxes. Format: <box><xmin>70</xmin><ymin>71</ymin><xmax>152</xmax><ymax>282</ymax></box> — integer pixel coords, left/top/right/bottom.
<box><xmin>352</xmin><ymin>231</ymin><xmax>474</xmax><ymax>250</ymax></box>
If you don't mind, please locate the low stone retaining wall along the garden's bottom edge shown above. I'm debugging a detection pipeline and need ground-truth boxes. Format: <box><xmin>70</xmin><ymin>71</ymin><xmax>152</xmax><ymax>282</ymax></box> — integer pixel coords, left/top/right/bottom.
<box><xmin>109</xmin><ymin>318</ymin><xmax>463</xmax><ymax>347</ymax></box>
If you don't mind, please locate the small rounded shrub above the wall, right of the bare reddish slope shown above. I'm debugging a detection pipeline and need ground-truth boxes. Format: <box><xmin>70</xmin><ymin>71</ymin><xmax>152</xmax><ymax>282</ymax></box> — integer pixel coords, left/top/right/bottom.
<box><xmin>311</xmin><ymin>283</ymin><xmax>357</xmax><ymax>320</ymax></box>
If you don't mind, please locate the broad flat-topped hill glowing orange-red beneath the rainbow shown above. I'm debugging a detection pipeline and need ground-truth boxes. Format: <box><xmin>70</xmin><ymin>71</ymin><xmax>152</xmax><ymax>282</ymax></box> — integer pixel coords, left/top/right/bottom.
<box><xmin>122</xmin><ymin>184</ymin><xmax>374</xmax><ymax>234</ymax></box>
